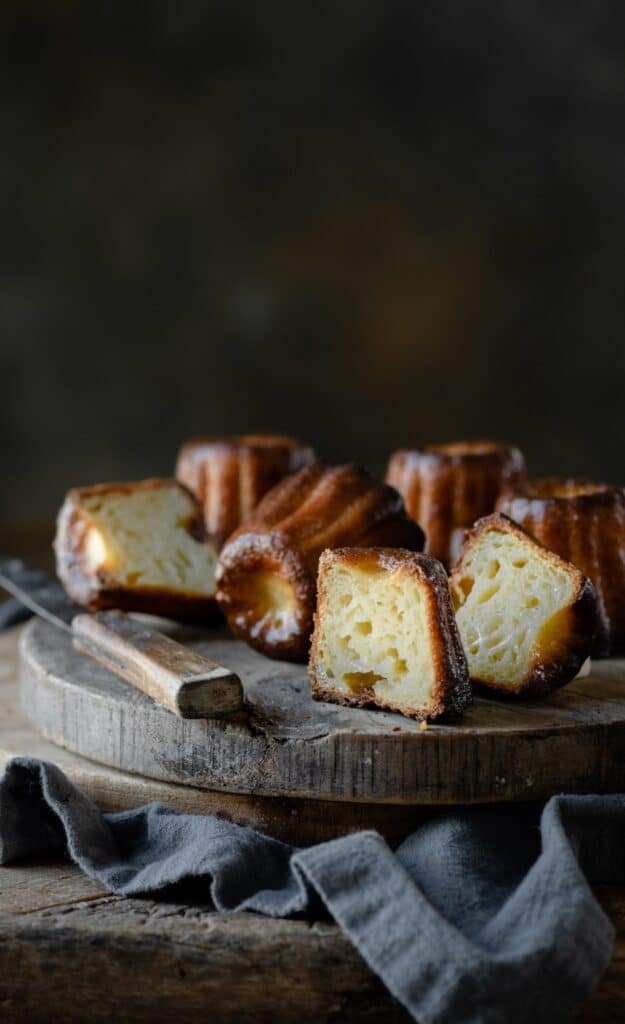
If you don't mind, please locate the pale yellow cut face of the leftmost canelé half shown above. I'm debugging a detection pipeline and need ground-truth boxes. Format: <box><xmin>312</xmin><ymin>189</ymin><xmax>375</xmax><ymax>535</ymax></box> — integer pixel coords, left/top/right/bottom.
<box><xmin>81</xmin><ymin>486</ymin><xmax>217</xmax><ymax>596</ymax></box>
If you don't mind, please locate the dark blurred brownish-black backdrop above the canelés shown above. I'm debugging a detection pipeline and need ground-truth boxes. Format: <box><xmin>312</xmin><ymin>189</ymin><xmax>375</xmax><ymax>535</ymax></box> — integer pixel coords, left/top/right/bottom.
<box><xmin>0</xmin><ymin>0</ymin><xmax>625</xmax><ymax>565</ymax></box>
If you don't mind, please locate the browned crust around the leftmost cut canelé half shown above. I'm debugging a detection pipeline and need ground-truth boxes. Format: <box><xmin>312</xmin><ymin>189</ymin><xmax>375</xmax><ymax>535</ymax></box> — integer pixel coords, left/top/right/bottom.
<box><xmin>54</xmin><ymin>477</ymin><xmax>219</xmax><ymax>623</ymax></box>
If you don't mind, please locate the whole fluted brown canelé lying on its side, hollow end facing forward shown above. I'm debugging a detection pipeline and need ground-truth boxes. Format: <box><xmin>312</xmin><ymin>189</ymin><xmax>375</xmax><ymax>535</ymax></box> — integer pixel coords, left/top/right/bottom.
<box><xmin>217</xmin><ymin>463</ymin><xmax>423</xmax><ymax>660</ymax></box>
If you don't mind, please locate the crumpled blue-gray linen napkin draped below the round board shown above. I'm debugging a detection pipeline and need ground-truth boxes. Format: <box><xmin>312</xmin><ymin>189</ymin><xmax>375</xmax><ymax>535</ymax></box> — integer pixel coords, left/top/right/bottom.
<box><xmin>0</xmin><ymin>758</ymin><xmax>614</xmax><ymax>1024</ymax></box>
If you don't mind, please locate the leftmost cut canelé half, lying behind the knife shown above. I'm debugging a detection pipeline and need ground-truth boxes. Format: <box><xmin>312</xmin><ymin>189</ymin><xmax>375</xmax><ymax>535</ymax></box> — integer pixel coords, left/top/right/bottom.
<box><xmin>54</xmin><ymin>479</ymin><xmax>217</xmax><ymax>622</ymax></box>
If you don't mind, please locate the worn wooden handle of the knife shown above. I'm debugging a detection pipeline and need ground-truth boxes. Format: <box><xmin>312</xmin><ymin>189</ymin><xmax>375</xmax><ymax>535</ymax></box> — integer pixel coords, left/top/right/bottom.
<box><xmin>72</xmin><ymin>611</ymin><xmax>243</xmax><ymax>718</ymax></box>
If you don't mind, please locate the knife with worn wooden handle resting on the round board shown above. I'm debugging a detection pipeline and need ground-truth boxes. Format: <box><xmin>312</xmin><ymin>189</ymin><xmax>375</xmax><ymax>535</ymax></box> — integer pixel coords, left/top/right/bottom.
<box><xmin>0</xmin><ymin>556</ymin><xmax>243</xmax><ymax>718</ymax></box>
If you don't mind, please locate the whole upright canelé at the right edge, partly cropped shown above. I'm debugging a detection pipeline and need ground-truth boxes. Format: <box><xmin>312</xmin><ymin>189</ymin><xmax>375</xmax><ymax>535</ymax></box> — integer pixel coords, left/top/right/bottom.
<box><xmin>497</xmin><ymin>477</ymin><xmax>625</xmax><ymax>657</ymax></box>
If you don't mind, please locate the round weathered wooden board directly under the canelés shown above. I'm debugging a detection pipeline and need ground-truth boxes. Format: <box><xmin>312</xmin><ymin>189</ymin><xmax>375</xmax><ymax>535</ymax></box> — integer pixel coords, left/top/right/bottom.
<box><xmin>20</xmin><ymin>621</ymin><xmax>625</xmax><ymax>805</ymax></box>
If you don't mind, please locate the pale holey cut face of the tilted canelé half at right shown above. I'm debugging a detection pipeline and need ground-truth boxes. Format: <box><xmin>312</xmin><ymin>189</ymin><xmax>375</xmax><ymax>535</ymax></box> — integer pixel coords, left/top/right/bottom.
<box><xmin>452</xmin><ymin>530</ymin><xmax>576</xmax><ymax>690</ymax></box>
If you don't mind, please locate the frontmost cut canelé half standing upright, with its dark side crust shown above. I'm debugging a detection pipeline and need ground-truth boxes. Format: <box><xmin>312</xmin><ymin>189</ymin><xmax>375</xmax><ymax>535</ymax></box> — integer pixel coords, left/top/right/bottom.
<box><xmin>309</xmin><ymin>548</ymin><xmax>470</xmax><ymax>720</ymax></box>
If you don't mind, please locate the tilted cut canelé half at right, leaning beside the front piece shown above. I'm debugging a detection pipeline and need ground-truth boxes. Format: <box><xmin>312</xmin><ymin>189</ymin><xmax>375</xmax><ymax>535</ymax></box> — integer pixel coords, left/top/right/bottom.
<box><xmin>450</xmin><ymin>514</ymin><xmax>596</xmax><ymax>696</ymax></box>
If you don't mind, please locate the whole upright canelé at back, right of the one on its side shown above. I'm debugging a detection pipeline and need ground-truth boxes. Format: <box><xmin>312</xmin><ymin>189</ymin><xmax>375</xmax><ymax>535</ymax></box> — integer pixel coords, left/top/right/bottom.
<box><xmin>386</xmin><ymin>441</ymin><xmax>526</xmax><ymax>569</ymax></box>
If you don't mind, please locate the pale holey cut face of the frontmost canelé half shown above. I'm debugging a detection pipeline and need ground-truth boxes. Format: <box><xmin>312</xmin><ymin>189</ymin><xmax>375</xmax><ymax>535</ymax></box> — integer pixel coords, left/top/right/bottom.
<box><xmin>317</xmin><ymin>564</ymin><xmax>435</xmax><ymax>711</ymax></box>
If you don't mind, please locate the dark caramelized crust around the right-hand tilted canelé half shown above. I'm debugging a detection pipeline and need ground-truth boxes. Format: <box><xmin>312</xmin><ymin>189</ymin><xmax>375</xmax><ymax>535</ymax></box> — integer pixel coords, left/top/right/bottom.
<box><xmin>450</xmin><ymin>513</ymin><xmax>597</xmax><ymax>697</ymax></box>
